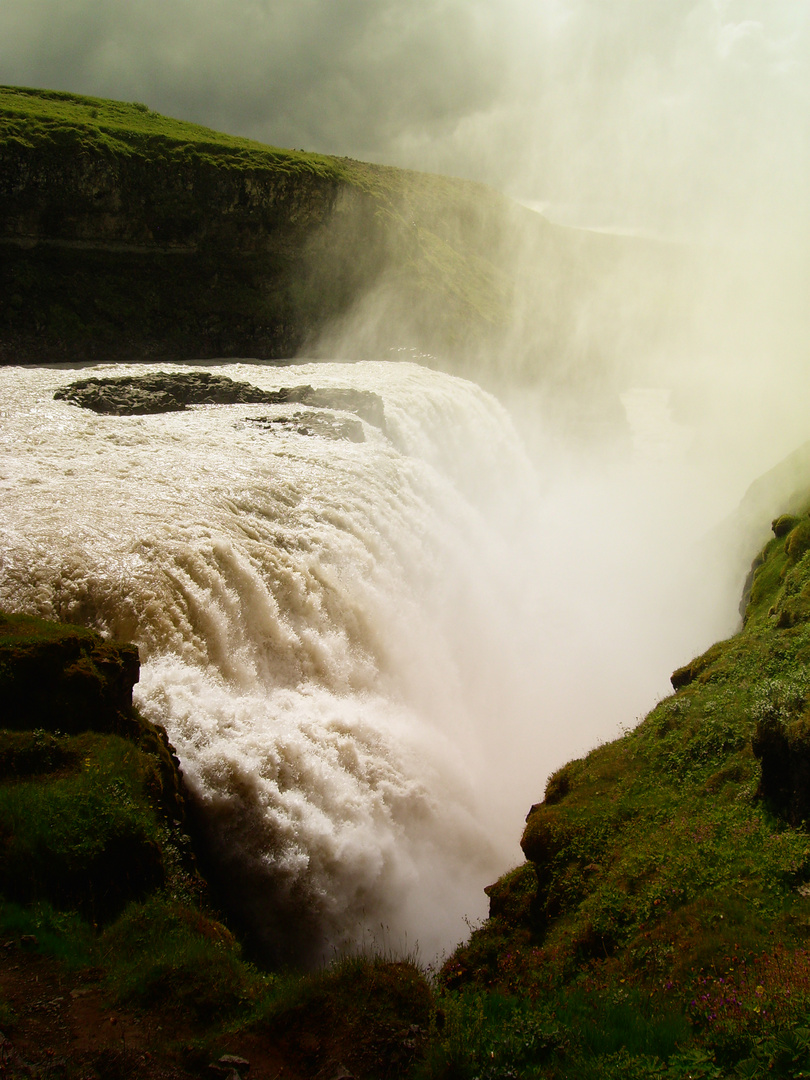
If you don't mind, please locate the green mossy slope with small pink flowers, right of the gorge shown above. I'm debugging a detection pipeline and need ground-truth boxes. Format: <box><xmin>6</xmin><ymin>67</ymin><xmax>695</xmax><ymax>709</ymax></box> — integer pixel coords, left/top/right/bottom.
<box><xmin>444</xmin><ymin>516</ymin><xmax>810</xmax><ymax>1077</ymax></box>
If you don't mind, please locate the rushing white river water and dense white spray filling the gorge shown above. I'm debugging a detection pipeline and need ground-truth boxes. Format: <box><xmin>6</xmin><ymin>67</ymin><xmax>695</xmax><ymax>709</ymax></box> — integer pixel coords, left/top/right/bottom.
<box><xmin>0</xmin><ymin>363</ymin><xmax>767</xmax><ymax>961</ymax></box>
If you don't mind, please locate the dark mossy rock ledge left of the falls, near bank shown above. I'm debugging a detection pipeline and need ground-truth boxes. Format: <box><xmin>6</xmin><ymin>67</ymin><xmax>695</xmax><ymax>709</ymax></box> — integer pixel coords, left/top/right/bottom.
<box><xmin>0</xmin><ymin>612</ymin><xmax>193</xmax><ymax>922</ymax></box>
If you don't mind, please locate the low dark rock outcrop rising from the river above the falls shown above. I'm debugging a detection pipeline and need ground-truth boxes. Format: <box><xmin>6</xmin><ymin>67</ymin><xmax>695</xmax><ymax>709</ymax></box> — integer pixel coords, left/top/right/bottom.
<box><xmin>54</xmin><ymin>372</ymin><xmax>386</xmax><ymax>432</ymax></box>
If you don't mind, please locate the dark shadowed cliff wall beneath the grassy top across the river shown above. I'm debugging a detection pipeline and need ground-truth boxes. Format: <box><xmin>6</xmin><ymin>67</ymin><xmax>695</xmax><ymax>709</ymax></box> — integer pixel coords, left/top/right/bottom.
<box><xmin>0</xmin><ymin>125</ymin><xmax>388</xmax><ymax>363</ymax></box>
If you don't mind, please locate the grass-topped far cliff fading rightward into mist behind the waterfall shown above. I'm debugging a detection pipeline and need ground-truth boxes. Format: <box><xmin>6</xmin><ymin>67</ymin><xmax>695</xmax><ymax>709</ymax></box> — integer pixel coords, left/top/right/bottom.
<box><xmin>0</xmin><ymin>86</ymin><xmax>693</xmax><ymax>393</ymax></box>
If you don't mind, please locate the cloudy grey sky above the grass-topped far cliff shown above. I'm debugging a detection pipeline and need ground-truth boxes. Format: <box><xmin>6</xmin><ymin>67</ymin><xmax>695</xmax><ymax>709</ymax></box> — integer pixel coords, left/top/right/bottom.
<box><xmin>0</xmin><ymin>0</ymin><xmax>810</xmax><ymax>240</ymax></box>
